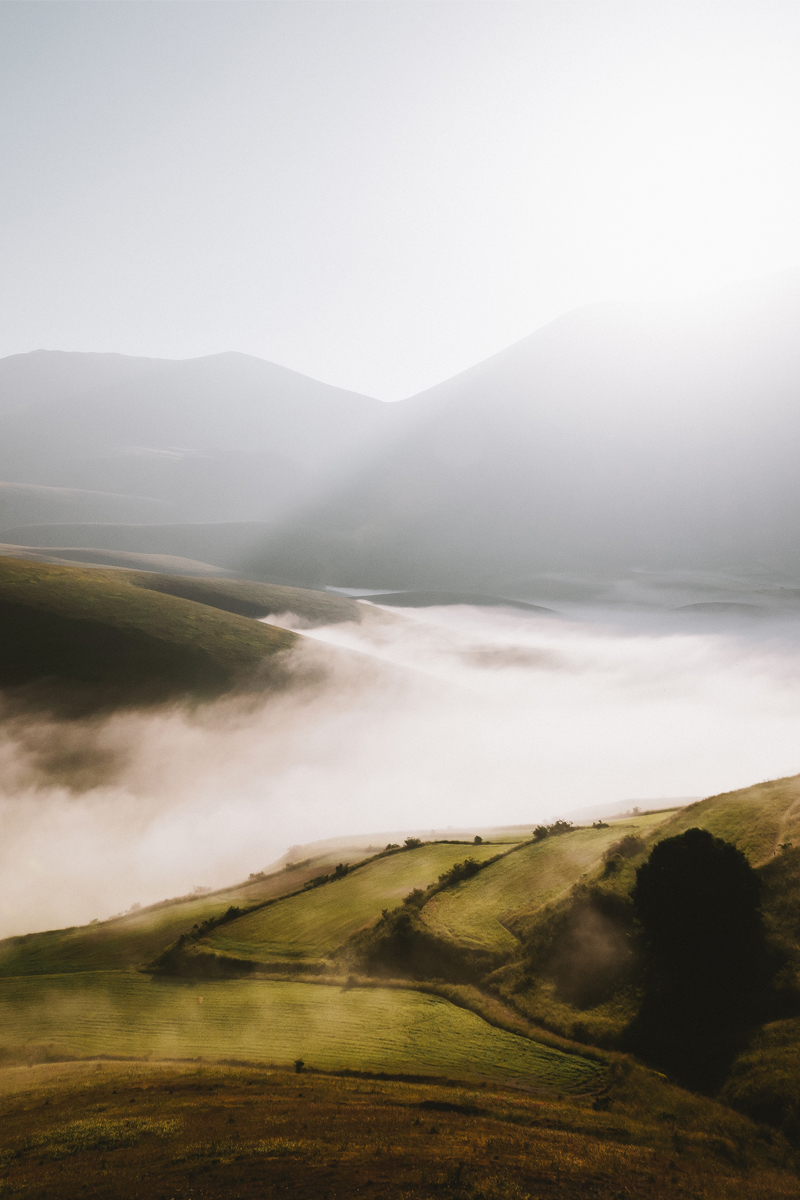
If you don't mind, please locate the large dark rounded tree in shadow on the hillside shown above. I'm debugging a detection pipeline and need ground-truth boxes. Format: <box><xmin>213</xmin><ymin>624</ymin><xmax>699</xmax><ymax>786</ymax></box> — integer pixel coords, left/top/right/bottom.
<box><xmin>630</xmin><ymin>829</ymin><xmax>769</xmax><ymax>1090</ymax></box>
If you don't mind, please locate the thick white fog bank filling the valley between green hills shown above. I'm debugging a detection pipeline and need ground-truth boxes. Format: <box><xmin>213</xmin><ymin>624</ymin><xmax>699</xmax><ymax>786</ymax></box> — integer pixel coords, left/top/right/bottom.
<box><xmin>0</xmin><ymin>607</ymin><xmax>800</xmax><ymax>934</ymax></box>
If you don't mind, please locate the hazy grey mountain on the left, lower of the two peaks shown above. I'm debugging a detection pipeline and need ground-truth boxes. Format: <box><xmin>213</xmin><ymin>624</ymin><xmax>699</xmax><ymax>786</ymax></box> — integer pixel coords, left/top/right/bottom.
<box><xmin>0</xmin><ymin>350</ymin><xmax>387</xmax><ymax>527</ymax></box>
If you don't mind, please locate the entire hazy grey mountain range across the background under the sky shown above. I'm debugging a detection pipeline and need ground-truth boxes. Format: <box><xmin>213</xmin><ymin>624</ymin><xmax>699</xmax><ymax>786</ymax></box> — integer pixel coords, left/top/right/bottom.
<box><xmin>0</xmin><ymin>278</ymin><xmax>800</xmax><ymax>606</ymax></box>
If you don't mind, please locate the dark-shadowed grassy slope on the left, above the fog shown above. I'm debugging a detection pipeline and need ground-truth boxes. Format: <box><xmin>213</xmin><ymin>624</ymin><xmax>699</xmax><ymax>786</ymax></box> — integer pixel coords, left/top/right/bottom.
<box><xmin>0</xmin><ymin>558</ymin><xmax>296</xmax><ymax>703</ymax></box>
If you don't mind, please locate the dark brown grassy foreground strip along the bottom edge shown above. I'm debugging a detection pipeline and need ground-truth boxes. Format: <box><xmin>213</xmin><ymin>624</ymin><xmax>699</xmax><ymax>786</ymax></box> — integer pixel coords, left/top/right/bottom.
<box><xmin>0</xmin><ymin>1062</ymin><xmax>798</xmax><ymax>1200</ymax></box>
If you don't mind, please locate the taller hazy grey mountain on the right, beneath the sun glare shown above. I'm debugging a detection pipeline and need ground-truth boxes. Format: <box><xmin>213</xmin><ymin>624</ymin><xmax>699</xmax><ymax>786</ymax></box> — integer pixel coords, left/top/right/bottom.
<box><xmin>307</xmin><ymin>288</ymin><xmax>800</xmax><ymax>596</ymax></box>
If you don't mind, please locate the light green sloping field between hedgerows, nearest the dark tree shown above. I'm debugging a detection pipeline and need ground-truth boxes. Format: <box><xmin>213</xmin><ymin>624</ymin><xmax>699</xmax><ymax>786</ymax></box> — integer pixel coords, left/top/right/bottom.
<box><xmin>422</xmin><ymin>814</ymin><xmax>668</xmax><ymax>954</ymax></box>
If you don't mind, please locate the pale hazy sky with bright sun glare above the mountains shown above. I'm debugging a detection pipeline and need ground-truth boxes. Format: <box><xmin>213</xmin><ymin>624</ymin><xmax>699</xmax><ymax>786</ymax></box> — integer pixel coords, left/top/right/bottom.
<box><xmin>0</xmin><ymin>0</ymin><xmax>800</xmax><ymax>398</ymax></box>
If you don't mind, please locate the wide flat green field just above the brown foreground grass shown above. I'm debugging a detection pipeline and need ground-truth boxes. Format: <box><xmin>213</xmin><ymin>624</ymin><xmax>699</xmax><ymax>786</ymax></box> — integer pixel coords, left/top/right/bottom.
<box><xmin>0</xmin><ymin>972</ymin><xmax>602</xmax><ymax>1091</ymax></box>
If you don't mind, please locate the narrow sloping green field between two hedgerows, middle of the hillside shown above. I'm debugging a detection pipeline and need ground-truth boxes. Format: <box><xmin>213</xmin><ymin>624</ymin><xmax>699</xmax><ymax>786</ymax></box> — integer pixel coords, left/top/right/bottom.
<box><xmin>206</xmin><ymin>844</ymin><xmax>506</xmax><ymax>962</ymax></box>
